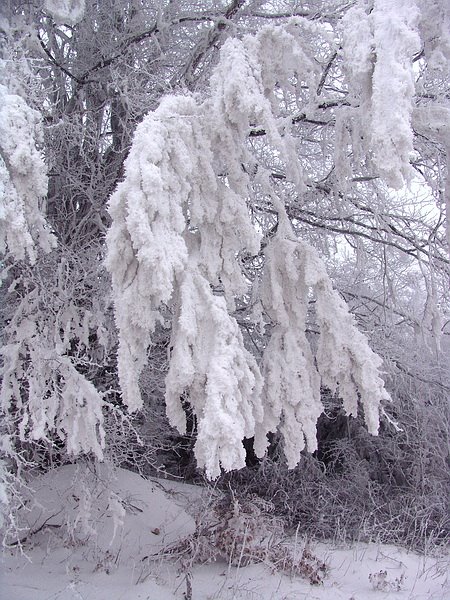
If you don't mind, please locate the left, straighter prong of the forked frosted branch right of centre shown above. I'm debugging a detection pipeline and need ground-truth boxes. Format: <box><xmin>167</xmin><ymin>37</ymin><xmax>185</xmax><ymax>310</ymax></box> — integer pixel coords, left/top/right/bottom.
<box><xmin>255</xmin><ymin>236</ymin><xmax>323</xmax><ymax>468</ymax></box>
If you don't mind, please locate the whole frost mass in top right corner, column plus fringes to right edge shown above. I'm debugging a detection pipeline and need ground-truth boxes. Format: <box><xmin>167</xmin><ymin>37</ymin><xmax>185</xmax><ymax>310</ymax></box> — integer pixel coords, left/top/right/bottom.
<box><xmin>342</xmin><ymin>0</ymin><xmax>450</xmax><ymax>240</ymax></box>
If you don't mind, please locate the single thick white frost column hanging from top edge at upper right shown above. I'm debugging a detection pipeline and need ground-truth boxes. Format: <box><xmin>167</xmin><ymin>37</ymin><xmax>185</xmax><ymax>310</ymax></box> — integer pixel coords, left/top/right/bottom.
<box><xmin>337</xmin><ymin>0</ymin><xmax>421</xmax><ymax>189</ymax></box>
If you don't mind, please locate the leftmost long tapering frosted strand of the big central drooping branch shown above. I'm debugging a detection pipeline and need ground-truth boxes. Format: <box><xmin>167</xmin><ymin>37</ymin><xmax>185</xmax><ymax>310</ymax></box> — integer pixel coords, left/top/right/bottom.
<box><xmin>106</xmin><ymin>97</ymin><xmax>199</xmax><ymax>410</ymax></box>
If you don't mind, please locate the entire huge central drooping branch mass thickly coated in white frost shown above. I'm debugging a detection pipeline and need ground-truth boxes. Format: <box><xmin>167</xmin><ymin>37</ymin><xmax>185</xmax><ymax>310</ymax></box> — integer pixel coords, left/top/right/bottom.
<box><xmin>106</xmin><ymin>19</ymin><xmax>388</xmax><ymax>477</ymax></box>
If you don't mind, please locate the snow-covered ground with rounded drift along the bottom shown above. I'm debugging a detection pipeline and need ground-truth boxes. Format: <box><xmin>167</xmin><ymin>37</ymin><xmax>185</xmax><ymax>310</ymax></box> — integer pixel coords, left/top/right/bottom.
<box><xmin>0</xmin><ymin>466</ymin><xmax>450</xmax><ymax>600</ymax></box>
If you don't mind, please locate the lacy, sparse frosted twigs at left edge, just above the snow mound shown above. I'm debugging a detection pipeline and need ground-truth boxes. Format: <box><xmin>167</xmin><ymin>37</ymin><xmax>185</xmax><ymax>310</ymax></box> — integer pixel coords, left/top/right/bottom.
<box><xmin>0</xmin><ymin>276</ymin><xmax>105</xmax><ymax>460</ymax></box>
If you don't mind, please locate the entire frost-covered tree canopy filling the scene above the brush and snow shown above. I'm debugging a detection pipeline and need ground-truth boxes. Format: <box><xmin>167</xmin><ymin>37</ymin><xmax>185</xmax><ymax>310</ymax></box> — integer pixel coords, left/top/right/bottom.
<box><xmin>0</xmin><ymin>0</ymin><xmax>450</xmax><ymax>500</ymax></box>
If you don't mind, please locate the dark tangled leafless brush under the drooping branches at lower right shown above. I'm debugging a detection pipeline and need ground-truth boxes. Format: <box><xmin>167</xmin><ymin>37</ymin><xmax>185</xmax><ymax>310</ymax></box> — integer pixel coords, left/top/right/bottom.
<box><xmin>215</xmin><ymin>382</ymin><xmax>450</xmax><ymax>552</ymax></box>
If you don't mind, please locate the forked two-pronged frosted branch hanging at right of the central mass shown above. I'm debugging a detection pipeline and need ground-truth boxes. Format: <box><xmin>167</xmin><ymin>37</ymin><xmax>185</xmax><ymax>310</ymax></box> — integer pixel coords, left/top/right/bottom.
<box><xmin>255</xmin><ymin>231</ymin><xmax>389</xmax><ymax>467</ymax></box>
